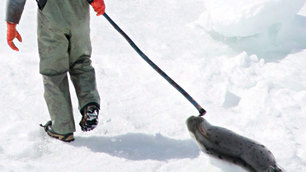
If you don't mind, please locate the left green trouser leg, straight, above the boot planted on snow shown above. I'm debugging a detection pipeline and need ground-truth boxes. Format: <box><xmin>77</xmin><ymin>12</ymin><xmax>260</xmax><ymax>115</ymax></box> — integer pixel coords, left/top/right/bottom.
<box><xmin>37</xmin><ymin>0</ymin><xmax>75</xmax><ymax>134</ymax></box>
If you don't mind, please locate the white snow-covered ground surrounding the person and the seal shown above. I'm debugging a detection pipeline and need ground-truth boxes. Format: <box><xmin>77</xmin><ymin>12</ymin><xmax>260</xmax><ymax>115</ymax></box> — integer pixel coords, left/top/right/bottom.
<box><xmin>0</xmin><ymin>0</ymin><xmax>306</xmax><ymax>172</ymax></box>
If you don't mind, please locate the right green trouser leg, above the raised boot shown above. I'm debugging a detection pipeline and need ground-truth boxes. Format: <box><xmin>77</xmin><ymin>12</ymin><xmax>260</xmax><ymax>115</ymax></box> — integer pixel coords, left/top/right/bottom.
<box><xmin>69</xmin><ymin>0</ymin><xmax>100</xmax><ymax>112</ymax></box>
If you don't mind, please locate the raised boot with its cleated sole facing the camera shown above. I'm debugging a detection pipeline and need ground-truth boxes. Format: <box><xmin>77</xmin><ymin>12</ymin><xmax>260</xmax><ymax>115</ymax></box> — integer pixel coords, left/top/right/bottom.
<box><xmin>80</xmin><ymin>105</ymin><xmax>99</xmax><ymax>131</ymax></box>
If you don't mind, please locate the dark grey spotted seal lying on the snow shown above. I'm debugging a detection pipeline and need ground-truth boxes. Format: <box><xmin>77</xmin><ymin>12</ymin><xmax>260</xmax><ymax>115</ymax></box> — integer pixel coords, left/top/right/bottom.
<box><xmin>186</xmin><ymin>116</ymin><xmax>283</xmax><ymax>172</ymax></box>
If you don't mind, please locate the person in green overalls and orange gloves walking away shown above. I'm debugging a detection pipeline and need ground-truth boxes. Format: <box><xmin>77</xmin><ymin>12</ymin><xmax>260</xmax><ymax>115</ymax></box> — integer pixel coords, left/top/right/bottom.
<box><xmin>6</xmin><ymin>0</ymin><xmax>105</xmax><ymax>142</ymax></box>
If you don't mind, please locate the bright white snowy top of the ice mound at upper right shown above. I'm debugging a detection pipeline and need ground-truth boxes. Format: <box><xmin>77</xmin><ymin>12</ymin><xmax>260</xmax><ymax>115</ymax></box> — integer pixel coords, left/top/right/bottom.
<box><xmin>197</xmin><ymin>0</ymin><xmax>305</xmax><ymax>36</ymax></box>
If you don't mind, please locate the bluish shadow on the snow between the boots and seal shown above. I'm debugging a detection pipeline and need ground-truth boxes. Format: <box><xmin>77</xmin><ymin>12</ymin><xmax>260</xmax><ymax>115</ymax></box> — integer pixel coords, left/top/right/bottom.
<box><xmin>72</xmin><ymin>133</ymin><xmax>200</xmax><ymax>161</ymax></box>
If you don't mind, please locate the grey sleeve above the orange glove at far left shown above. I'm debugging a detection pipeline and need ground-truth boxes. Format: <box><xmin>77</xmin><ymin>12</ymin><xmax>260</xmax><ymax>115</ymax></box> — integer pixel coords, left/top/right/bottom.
<box><xmin>6</xmin><ymin>0</ymin><xmax>26</xmax><ymax>24</ymax></box>
